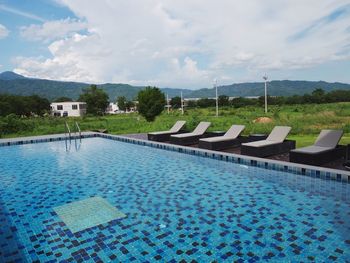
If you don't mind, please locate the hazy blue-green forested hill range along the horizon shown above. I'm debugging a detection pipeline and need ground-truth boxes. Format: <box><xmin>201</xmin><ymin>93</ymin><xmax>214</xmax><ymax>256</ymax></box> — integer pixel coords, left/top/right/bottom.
<box><xmin>0</xmin><ymin>71</ymin><xmax>350</xmax><ymax>101</ymax></box>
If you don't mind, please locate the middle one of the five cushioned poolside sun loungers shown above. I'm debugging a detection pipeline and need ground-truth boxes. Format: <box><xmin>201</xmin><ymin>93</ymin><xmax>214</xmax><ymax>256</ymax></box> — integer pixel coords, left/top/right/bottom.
<box><xmin>198</xmin><ymin>125</ymin><xmax>245</xmax><ymax>150</ymax></box>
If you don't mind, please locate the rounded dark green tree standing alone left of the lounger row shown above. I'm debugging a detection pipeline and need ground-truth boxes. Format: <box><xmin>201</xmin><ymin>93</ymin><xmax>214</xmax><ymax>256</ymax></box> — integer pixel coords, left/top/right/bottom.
<box><xmin>137</xmin><ymin>87</ymin><xmax>165</xmax><ymax>121</ymax></box>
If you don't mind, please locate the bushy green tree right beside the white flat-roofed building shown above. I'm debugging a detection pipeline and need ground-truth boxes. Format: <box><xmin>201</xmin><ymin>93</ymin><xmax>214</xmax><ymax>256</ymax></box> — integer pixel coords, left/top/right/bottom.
<box><xmin>79</xmin><ymin>85</ymin><xmax>109</xmax><ymax>115</ymax></box>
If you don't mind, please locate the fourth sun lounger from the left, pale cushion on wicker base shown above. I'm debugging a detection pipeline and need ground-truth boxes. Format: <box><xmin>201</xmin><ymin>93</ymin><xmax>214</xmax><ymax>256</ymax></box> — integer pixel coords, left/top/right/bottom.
<box><xmin>241</xmin><ymin>126</ymin><xmax>295</xmax><ymax>157</ymax></box>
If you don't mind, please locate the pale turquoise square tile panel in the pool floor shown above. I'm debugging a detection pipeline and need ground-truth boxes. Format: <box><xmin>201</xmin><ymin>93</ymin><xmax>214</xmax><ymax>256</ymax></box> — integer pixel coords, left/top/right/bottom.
<box><xmin>54</xmin><ymin>196</ymin><xmax>126</xmax><ymax>233</ymax></box>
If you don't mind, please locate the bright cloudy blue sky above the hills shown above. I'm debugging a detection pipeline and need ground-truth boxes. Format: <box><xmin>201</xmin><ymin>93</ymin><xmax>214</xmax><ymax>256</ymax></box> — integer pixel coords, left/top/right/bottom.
<box><xmin>0</xmin><ymin>0</ymin><xmax>350</xmax><ymax>89</ymax></box>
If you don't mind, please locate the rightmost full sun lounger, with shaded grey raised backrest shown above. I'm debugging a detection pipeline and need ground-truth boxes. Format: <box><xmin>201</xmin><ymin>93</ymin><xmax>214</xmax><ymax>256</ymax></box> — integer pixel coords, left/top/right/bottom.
<box><xmin>289</xmin><ymin>130</ymin><xmax>346</xmax><ymax>165</ymax></box>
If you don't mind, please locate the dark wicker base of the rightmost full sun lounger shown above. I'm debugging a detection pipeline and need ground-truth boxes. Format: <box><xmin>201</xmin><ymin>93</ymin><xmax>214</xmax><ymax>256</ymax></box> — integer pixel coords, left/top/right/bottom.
<box><xmin>289</xmin><ymin>145</ymin><xmax>346</xmax><ymax>165</ymax></box>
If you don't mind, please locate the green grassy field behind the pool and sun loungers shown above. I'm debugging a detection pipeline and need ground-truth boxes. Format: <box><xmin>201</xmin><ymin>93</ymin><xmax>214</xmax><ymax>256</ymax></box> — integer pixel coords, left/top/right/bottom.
<box><xmin>3</xmin><ymin>103</ymin><xmax>350</xmax><ymax>147</ymax></box>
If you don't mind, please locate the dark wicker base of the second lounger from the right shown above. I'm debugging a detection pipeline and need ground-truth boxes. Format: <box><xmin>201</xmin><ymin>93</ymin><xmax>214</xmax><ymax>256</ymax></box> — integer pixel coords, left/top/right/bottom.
<box><xmin>241</xmin><ymin>140</ymin><xmax>295</xmax><ymax>157</ymax></box>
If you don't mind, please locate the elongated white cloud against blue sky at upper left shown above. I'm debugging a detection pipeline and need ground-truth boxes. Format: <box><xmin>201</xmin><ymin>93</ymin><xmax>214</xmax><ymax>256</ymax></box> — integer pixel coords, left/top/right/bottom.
<box><xmin>21</xmin><ymin>18</ymin><xmax>87</xmax><ymax>42</ymax></box>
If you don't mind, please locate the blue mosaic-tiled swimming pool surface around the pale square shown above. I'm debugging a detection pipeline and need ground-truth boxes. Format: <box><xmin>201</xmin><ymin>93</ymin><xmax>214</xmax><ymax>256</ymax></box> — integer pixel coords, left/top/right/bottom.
<box><xmin>0</xmin><ymin>138</ymin><xmax>350</xmax><ymax>262</ymax></box>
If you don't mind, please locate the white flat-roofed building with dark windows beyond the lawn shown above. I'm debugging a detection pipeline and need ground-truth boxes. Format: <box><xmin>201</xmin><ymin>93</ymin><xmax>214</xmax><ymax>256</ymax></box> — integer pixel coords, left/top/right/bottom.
<box><xmin>50</xmin><ymin>101</ymin><xmax>86</xmax><ymax>117</ymax></box>
